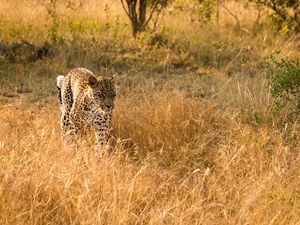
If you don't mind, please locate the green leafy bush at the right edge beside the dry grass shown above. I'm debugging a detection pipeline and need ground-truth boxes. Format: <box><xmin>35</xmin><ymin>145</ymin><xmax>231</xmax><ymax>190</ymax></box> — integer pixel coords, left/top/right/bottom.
<box><xmin>266</xmin><ymin>56</ymin><xmax>300</xmax><ymax>113</ymax></box>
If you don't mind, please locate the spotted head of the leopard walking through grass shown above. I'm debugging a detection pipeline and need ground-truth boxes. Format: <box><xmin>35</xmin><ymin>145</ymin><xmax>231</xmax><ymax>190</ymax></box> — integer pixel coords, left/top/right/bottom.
<box><xmin>88</xmin><ymin>75</ymin><xmax>116</xmax><ymax>113</ymax></box>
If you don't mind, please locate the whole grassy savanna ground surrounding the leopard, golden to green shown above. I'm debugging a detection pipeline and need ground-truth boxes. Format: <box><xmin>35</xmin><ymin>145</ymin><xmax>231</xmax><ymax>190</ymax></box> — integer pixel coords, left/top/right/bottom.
<box><xmin>0</xmin><ymin>0</ymin><xmax>300</xmax><ymax>225</ymax></box>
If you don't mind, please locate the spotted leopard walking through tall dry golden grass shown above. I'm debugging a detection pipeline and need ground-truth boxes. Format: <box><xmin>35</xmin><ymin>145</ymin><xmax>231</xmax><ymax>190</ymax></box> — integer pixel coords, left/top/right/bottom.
<box><xmin>56</xmin><ymin>67</ymin><xmax>116</xmax><ymax>152</ymax></box>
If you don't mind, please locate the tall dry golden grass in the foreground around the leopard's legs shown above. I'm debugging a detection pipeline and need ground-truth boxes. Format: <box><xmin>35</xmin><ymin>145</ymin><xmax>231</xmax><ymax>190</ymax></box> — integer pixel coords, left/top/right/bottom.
<box><xmin>0</xmin><ymin>92</ymin><xmax>300</xmax><ymax>224</ymax></box>
